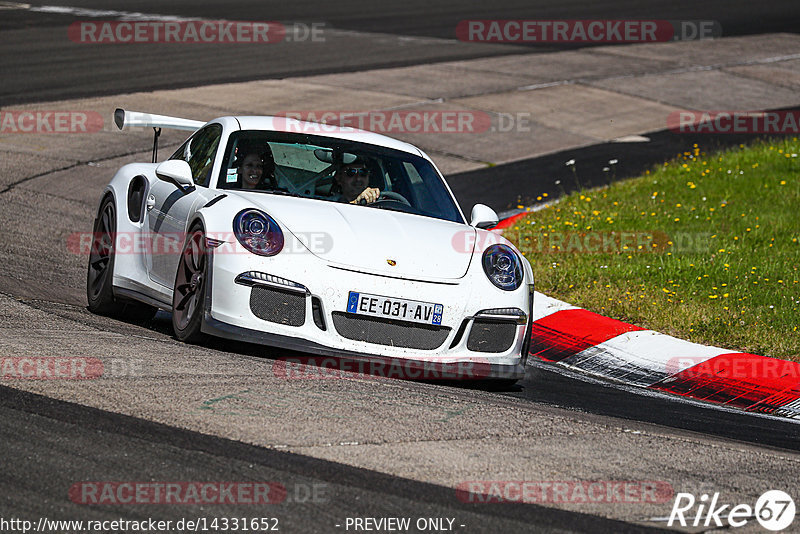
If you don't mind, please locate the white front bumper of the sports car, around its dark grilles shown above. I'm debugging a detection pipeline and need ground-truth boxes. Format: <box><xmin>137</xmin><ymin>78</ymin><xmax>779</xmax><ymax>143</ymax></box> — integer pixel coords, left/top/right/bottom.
<box><xmin>202</xmin><ymin>241</ymin><xmax>533</xmax><ymax>380</ymax></box>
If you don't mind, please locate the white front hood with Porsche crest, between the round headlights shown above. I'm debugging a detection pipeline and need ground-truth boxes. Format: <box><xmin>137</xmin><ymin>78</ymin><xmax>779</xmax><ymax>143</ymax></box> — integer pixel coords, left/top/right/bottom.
<box><xmin>239</xmin><ymin>193</ymin><xmax>475</xmax><ymax>279</ymax></box>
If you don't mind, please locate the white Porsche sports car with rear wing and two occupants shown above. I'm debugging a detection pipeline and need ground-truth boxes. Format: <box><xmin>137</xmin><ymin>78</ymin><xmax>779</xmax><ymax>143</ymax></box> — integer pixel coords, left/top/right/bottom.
<box><xmin>87</xmin><ymin>109</ymin><xmax>533</xmax><ymax>381</ymax></box>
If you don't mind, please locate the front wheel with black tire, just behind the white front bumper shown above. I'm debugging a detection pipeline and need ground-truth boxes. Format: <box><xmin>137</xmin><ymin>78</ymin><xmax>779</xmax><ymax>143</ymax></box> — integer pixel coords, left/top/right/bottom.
<box><xmin>172</xmin><ymin>225</ymin><xmax>208</xmax><ymax>343</ymax></box>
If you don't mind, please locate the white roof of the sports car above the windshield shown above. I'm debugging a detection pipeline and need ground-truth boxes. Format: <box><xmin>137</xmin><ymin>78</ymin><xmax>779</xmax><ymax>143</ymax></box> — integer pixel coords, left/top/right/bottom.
<box><xmin>223</xmin><ymin>115</ymin><xmax>424</xmax><ymax>157</ymax></box>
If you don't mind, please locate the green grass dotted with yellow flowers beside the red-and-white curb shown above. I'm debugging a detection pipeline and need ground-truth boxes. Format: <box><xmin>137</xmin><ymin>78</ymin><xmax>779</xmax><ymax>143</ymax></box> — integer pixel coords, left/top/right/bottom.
<box><xmin>505</xmin><ymin>138</ymin><xmax>800</xmax><ymax>361</ymax></box>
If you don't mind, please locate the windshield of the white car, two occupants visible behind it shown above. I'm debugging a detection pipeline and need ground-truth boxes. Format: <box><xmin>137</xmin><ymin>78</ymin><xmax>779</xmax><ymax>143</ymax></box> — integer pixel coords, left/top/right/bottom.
<box><xmin>218</xmin><ymin>130</ymin><xmax>464</xmax><ymax>223</ymax></box>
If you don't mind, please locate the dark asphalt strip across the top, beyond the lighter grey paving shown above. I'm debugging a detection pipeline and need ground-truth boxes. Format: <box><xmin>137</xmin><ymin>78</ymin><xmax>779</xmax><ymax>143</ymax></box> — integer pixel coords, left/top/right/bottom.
<box><xmin>0</xmin><ymin>0</ymin><xmax>800</xmax><ymax>107</ymax></box>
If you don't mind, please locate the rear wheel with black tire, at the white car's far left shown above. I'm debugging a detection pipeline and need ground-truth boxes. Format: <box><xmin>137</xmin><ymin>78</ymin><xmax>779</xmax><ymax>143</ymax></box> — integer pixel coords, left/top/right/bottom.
<box><xmin>86</xmin><ymin>196</ymin><xmax>157</xmax><ymax>322</ymax></box>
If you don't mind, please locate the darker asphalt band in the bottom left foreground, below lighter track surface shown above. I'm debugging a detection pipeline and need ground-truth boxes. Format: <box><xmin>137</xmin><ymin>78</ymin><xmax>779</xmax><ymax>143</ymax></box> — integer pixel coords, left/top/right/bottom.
<box><xmin>0</xmin><ymin>387</ymin><xmax>676</xmax><ymax>533</ymax></box>
